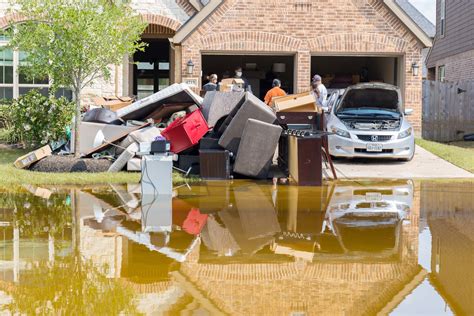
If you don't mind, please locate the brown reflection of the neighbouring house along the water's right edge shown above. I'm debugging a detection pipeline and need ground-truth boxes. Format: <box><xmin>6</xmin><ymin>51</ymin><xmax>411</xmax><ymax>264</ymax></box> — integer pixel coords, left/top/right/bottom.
<box><xmin>421</xmin><ymin>183</ymin><xmax>474</xmax><ymax>315</ymax></box>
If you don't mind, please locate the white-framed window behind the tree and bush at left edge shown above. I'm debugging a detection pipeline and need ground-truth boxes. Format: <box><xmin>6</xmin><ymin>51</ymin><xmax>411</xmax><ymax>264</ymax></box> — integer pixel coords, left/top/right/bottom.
<box><xmin>0</xmin><ymin>34</ymin><xmax>72</xmax><ymax>100</ymax></box>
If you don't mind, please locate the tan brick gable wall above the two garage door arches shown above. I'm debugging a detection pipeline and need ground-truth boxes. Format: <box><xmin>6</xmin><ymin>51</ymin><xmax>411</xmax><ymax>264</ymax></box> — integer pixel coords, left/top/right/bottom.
<box><xmin>174</xmin><ymin>0</ymin><xmax>430</xmax><ymax>46</ymax></box>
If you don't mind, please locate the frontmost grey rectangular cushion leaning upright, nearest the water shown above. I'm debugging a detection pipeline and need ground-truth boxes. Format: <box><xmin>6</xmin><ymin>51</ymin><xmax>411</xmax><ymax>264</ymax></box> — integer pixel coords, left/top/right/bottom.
<box><xmin>234</xmin><ymin>119</ymin><xmax>283</xmax><ymax>178</ymax></box>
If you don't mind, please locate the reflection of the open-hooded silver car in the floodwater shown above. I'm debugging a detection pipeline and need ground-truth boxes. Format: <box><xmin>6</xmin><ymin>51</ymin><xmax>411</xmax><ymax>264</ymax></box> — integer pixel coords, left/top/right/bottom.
<box><xmin>326</xmin><ymin>181</ymin><xmax>413</xmax><ymax>254</ymax></box>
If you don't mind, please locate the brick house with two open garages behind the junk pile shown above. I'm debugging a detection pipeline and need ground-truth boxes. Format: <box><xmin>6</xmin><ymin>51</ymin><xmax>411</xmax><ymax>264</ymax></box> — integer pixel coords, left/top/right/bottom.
<box><xmin>0</xmin><ymin>0</ymin><xmax>431</xmax><ymax>131</ymax></box>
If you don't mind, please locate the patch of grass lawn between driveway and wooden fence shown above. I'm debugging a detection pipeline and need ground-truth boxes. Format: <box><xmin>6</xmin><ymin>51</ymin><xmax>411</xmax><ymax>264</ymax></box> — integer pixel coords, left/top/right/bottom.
<box><xmin>416</xmin><ymin>138</ymin><xmax>474</xmax><ymax>173</ymax></box>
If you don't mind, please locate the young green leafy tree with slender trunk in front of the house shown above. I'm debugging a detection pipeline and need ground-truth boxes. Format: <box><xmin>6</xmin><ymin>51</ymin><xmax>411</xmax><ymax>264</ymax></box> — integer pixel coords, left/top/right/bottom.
<box><xmin>10</xmin><ymin>0</ymin><xmax>147</xmax><ymax>156</ymax></box>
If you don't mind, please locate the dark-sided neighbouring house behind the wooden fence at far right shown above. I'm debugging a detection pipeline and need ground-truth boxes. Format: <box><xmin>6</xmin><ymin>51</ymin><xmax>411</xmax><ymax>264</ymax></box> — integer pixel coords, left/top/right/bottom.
<box><xmin>427</xmin><ymin>0</ymin><xmax>474</xmax><ymax>82</ymax></box>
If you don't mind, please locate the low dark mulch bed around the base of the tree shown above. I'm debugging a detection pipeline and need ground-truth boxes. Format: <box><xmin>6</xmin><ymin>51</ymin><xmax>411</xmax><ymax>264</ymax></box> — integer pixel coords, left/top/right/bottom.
<box><xmin>30</xmin><ymin>155</ymin><xmax>112</xmax><ymax>172</ymax></box>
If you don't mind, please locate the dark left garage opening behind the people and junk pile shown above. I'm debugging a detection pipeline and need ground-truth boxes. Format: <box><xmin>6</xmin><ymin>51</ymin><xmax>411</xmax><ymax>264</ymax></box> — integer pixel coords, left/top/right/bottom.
<box><xmin>202</xmin><ymin>54</ymin><xmax>294</xmax><ymax>99</ymax></box>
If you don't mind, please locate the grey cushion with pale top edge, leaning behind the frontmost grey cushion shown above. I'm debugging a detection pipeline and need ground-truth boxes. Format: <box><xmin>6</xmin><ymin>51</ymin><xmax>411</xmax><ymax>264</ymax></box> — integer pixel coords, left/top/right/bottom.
<box><xmin>219</xmin><ymin>92</ymin><xmax>277</xmax><ymax>153</ymax></box>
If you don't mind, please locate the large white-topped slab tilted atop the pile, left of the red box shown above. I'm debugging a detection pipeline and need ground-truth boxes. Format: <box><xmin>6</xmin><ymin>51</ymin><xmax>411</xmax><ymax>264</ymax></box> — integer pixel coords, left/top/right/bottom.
<box><xmin>117</xmin><ymin>83</ymin><xmax>203</xmax><ymax>120</ymax></box>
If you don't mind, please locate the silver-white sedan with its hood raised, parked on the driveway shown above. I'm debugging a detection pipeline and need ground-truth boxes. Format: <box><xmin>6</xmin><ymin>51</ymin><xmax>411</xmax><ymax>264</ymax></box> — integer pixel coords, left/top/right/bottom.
<box><xmin>326</xmin><ymin>83</ymin><xmax>415</xmax><ymax>161</ymax></box>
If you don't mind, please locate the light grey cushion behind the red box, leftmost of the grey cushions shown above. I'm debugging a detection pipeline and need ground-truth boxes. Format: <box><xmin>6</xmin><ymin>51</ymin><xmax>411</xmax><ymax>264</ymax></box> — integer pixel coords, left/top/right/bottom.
<box><xmin>202</xmin><ymin>92</ymin><xmax>245</xmax><ymax>128</ymax></box>
